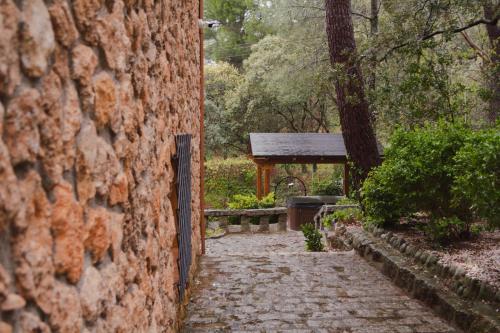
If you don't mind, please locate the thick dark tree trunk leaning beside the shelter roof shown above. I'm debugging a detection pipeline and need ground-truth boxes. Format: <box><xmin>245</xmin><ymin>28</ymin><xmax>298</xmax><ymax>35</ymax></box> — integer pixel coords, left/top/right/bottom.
<box><xmin>325</xmin><ymin>0</ymin><xmax>380</xmax><ymax>186</ymax></box>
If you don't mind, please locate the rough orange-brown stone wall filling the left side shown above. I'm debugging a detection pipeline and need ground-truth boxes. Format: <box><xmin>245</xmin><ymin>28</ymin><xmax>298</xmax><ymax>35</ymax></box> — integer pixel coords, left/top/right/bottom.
<box><xmin>0</xmin><ymin>0</ymin><xmax>200</xmax><ymax>333</ymax></box>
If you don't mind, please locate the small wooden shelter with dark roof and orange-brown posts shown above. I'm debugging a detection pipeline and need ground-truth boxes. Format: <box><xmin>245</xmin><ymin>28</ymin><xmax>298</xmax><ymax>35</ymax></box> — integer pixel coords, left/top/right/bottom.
<box><xmin>250</xmin><ymin>133</ymin><xmax>349</xmax><ymax>199</ymax></box>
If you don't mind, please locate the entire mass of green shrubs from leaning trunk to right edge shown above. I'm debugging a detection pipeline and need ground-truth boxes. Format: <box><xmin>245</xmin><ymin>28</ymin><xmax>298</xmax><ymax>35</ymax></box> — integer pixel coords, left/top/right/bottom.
<box><xmin>362</xmin><ymin>123</ymin><xmax>500</xmax><ymax>243</ymax></box>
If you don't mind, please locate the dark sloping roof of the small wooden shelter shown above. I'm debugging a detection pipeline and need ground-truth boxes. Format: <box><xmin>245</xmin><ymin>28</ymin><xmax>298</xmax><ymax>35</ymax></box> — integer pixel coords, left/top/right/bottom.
<box><xmin>250</xmin><ymin>133</ymin><xmax>347</xmax><ymax>163</ymax></box>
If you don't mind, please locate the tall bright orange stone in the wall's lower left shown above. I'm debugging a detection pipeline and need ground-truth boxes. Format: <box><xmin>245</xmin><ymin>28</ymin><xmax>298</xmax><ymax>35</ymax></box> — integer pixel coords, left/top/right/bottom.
<box><xmin>52</xmin><ymin>183</ymin><xmax>84</xmax><ymax>283</ymax></box>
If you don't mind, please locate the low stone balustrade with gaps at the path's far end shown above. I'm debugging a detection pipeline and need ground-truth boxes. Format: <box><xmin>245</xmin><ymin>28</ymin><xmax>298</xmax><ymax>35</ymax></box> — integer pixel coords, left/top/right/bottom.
<box><xmin>205</xmin><ymin>207</ymin><xmax>287</xmax><ymax>235</ymax></box>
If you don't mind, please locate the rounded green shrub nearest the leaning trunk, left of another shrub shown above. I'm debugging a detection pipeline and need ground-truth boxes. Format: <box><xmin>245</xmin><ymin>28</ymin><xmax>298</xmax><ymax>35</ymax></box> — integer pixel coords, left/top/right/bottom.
<box><xmin>361</xmin><ymin>123</ymin><xmax>471</xmax><ymax>225</ymax></box>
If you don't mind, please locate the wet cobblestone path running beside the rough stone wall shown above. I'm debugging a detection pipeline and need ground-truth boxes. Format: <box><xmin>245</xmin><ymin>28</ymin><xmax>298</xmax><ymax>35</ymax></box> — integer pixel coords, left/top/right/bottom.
<box><xmin>183</xmin><ymin>232</ymin><xmax>459</xmax><ymax>333</ymax></box>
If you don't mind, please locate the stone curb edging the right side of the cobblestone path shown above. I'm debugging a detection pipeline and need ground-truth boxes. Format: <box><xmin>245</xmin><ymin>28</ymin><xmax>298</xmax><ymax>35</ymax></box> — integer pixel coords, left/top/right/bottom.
<box><xmin>336</xmin><ymin>226</ymin><xmax>500</xmax><ymax>333</ymax></box>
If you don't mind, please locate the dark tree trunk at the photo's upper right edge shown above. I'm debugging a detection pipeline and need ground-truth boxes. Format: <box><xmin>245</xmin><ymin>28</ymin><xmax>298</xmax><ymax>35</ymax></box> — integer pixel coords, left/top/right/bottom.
<box><xmin>483</xmin><ymin>1</ymin><xmax>500</xmax><ymax>124</ymax></box>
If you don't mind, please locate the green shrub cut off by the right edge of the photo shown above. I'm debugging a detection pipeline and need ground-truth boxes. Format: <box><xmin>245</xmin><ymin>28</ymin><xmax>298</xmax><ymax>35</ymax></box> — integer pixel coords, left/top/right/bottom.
<box><xmin>453</xmin><ymin>126</ymin><xmax>500</xmax><ymax>228</ymax></box>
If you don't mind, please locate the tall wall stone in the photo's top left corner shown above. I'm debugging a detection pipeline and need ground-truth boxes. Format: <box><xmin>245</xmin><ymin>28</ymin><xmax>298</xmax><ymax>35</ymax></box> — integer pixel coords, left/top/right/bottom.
<box><xmin>0</xmin><ymin>0</ymin><xmax>21</xmax><ymax>95</ymax></box>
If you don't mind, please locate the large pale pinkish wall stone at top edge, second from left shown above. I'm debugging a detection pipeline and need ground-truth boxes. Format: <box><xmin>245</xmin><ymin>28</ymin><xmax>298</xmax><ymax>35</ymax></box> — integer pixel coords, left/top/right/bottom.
<box><xmin>21</xmin><ymin>0</ymin><xmax>55</xmax><ymax>77</ymax></box>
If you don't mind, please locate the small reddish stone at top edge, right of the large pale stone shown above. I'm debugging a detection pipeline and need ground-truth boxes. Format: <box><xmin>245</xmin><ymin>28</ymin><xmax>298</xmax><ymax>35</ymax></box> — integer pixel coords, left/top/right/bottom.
<box><xmin>49</xmin><ymin>0</ymin><xmax>78</xmax><ymax>47</ymax></box>
